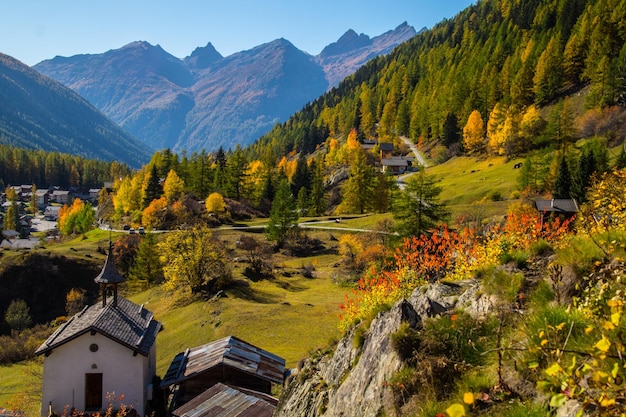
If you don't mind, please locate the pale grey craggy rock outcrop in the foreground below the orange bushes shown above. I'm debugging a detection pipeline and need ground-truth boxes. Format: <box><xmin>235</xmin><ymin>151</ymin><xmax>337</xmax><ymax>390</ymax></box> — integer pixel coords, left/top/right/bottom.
<box><xmin>274</xmin><ymin>281</ymin><xmax>492</xmax><ymax>417</ymax></box>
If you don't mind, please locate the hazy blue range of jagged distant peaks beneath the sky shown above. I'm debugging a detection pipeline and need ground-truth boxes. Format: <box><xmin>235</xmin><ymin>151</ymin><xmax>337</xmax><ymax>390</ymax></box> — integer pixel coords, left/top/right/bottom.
<box><xmin>34</xmin><ymin>23</ymin><xmax>416</xmax><ymax>152</ymax></box>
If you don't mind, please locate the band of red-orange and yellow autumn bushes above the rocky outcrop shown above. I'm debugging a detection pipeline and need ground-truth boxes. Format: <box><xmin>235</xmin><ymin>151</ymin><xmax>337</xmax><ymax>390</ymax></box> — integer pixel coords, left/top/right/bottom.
<box><xmin>340</xmin><ymin>211</ymin><xmax>571</xmax><ymax>331</ymax></box>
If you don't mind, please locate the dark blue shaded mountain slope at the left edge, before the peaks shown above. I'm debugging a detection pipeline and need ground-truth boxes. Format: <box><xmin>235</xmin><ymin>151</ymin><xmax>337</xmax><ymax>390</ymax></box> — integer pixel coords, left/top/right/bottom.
<box><xmin>0</xmin><ymin>54</ymin><xmax>150</xmax><ymax>167</ymax></box>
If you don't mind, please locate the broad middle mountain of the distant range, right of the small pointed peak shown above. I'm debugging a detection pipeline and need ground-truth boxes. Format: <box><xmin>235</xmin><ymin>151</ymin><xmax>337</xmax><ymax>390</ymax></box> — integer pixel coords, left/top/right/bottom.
<box><xmin>180</xmin><ymin>39</ymin><xmax>327</xmax><ymax>150</ymax></box>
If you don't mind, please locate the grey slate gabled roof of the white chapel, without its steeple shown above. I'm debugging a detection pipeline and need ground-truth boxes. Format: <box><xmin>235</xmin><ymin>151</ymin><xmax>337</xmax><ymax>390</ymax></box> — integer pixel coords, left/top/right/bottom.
<box><xmin>35</xmin><ymin>297</ymin><xmax>161</xmax><ymax>356</ymax></box>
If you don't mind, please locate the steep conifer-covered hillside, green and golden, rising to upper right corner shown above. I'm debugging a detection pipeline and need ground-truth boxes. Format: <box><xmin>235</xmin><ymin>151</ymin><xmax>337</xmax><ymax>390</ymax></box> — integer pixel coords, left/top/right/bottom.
<box><xmin>252</xmin><ymin>0</ymin><xmax>626</xmax><ymax>159</ymax></box>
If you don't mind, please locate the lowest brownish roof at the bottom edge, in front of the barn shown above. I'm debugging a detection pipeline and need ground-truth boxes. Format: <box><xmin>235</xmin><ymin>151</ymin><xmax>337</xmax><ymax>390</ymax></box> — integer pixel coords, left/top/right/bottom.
<box><xmin>172</xmin><ymin>383</ymin><xmax>277</xmax><ymax>417</ymax></box>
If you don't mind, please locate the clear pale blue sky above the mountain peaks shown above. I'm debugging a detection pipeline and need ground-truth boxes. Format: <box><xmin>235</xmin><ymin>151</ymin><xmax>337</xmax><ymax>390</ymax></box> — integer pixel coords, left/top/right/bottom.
<box><xmin>0</xmin><ymin>0</ymin><xmax>476</xmax><ymax>66</ymax></box>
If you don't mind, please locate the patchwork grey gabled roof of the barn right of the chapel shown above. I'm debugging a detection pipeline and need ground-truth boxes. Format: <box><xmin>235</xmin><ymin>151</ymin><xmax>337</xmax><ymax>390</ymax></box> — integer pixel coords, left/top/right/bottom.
<box><xmin>161</xmin><ymin>336</ymin><xmax>285</xmax><ymax>387</ymax></box>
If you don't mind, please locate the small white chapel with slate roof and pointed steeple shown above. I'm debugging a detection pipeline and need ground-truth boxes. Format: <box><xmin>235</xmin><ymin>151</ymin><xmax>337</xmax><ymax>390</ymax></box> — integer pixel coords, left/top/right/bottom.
<box><xmin>36</xmin><ymin>242</ymin><xmax>161</xmax><ymax>415</ymax></box>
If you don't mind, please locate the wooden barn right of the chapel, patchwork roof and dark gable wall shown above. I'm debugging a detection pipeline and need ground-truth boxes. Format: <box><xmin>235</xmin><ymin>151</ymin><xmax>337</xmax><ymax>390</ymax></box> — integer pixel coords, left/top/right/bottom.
<box><xmin>161</xmin><ymin>336</ymin><xmax>285</xmax><ymax>409</ymax></box>
